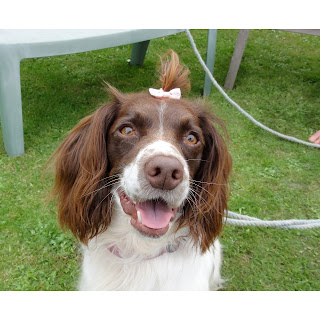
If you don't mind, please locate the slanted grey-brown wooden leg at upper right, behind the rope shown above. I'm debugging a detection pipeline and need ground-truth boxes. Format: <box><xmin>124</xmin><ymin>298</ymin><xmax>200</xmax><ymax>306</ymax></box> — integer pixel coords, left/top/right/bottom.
<box><xmin>224</xmin><ymin>29</ymin><xmax>250</xmax><ymax>90</ymax></box>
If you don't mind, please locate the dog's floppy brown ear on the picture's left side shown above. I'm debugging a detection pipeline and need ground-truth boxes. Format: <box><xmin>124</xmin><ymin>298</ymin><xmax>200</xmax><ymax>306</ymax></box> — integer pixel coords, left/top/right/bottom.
<box><xmin>52</xmin><ymin>101</ymin><xmax>119</xmax><ymax>243</ymax></box>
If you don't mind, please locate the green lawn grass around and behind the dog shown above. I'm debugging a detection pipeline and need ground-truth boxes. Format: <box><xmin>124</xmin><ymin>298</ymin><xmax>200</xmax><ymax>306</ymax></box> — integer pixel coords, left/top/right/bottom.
<box><xmin>0</xmin><ymin>30</ymin><xmax>320</xmax><ymax>290</ymax></box>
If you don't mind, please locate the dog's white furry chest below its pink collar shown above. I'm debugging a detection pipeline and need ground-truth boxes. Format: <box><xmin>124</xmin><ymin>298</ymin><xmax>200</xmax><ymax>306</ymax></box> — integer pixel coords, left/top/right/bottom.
<box><xmin>80</xmin><ymin>245</ymin><xmax>214</xmax><ymax>290</ymax></box>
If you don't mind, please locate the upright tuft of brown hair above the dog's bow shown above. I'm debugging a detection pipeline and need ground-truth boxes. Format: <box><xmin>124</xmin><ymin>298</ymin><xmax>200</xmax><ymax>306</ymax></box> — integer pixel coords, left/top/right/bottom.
<box><xmin>159</xmin><ymin>50</ymin><xmax>191</xmax><ymax>92</ymax></box>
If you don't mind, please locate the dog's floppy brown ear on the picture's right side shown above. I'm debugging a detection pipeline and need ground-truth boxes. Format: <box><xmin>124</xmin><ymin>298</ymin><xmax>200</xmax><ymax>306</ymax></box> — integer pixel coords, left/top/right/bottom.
<box><xmin>179</xmin><ymin>113</ymin><xmax>232</xmax><ymax>253</ymax></box>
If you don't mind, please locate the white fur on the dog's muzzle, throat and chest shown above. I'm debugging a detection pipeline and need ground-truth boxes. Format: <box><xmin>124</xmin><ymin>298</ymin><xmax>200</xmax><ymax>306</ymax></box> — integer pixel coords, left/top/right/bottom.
<box><xmin>79</xmin><ymin>140</ymin><xmax>222</xmax><ymax>290</ymax></box>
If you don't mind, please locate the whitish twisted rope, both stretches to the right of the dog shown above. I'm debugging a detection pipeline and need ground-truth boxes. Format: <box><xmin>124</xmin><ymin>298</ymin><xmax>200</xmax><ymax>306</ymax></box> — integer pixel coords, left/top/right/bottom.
<box><xmin>185</xmin><ymin>29</ymin><xmax>320</xmax><ymax>230</ymax></box>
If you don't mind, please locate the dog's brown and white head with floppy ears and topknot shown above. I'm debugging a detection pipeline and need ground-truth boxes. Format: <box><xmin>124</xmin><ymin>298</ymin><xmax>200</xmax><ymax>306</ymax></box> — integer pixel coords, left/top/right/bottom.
<box><xmin>54</xmin><ymin>52</ymin><xmax>231</xmax><ymax>252</ymax></box>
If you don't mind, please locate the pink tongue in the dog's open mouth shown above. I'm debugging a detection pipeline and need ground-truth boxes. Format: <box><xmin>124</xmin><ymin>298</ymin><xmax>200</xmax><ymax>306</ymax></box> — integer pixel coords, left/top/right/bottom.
<box><xmin>136</xmin><ymin>201</ymin><xmax>174</xmax><ymax>229</ymax></box>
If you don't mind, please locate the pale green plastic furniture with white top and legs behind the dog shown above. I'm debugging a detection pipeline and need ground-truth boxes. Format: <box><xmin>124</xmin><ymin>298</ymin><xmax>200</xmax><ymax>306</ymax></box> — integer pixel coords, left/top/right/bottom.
<box><xmin>0</xmin><ymin>29</ymin><xmax>216</xmax><ymax>156</ymax></box>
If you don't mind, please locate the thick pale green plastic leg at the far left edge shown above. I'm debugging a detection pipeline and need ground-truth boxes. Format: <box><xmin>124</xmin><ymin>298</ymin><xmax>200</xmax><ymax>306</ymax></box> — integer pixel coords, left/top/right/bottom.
<box><xmin>0</xmin><ymin>56</ymin><xmax>24</xmax><ymax>156</ymax></box>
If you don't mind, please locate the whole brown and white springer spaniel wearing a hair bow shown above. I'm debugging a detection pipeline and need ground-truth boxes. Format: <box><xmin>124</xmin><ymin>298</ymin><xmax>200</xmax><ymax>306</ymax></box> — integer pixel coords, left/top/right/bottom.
<box><xmin>53</xmin><ymin>51</ymin><xmax>231</xmax><ymax>290</ymax></box>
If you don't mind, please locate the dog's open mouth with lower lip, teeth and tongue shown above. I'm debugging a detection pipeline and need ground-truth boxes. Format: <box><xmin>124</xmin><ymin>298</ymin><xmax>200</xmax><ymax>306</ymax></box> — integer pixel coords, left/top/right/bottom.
<box><xmin>118</xmin><ymin>191</ymin><xmax>178</xmax><ymax>237</ymax></box>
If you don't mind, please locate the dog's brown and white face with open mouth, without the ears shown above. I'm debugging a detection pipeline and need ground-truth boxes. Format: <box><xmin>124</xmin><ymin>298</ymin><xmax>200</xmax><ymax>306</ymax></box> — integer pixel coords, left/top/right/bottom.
<box><xmin>107</xmin><ymin>94</ymin><xmax>205</xmax><ymax>237</ymax></box>
